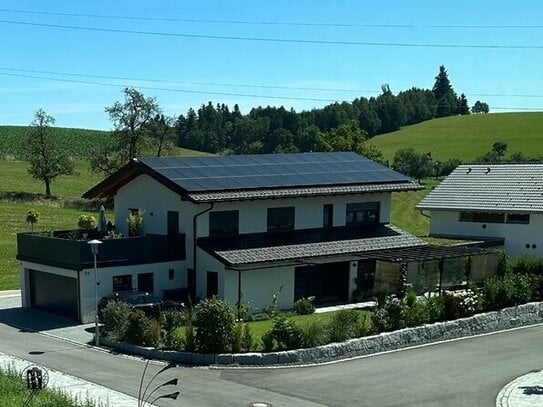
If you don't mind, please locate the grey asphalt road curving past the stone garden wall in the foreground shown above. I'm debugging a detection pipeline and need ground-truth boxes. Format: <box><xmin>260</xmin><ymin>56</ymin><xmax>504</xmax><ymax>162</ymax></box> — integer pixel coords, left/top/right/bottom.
<box><xmin>0</xmin><ymin>316</ymin><xmax>543</xmax><ymax>407</ymax></box>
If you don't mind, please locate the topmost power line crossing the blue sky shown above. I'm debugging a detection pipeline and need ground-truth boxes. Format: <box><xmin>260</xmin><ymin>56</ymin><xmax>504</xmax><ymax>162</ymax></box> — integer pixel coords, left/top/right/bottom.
<box><xmin>0</xmin><ymin>8</ymin><xmax>543</xmax><ymax>30</ymax></box>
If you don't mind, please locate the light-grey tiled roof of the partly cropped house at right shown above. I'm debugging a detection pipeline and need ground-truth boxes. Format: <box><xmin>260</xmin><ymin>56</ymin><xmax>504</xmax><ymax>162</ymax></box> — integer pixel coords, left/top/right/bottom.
<box><xmin>417</xmin><ymin>164</ymin><xmax>543</xmax><ymax>213</ymax></box>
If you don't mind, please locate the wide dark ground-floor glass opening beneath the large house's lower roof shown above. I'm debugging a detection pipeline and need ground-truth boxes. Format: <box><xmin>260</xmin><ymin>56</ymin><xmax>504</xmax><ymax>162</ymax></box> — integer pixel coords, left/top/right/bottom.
<box><xmin>294</xmin><ymin>262</ymin><xmax>349</xmax><ymax>304</ymax></box>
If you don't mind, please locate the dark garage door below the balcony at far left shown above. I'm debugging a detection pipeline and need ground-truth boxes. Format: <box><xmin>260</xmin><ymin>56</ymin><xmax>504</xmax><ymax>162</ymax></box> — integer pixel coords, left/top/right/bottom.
<box><xmin>29</xmin><ymin>270</ymin><xmax>79</xmax><ymax>319</ymax></box>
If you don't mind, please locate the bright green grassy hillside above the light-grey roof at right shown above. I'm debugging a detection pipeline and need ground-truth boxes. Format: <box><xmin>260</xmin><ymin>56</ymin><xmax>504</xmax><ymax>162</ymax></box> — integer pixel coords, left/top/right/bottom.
<box><xmin>372</xmin><ymin>112</ymin><xmax>543</xmax><ymax>162</ymax></box>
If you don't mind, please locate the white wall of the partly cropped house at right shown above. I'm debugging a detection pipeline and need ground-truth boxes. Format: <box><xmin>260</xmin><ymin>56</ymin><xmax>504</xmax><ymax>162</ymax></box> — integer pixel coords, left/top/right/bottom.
<box><xmin>430</xmin><ymin>211</ymin><xmax>543</xmax><ymax>257</ymax></box>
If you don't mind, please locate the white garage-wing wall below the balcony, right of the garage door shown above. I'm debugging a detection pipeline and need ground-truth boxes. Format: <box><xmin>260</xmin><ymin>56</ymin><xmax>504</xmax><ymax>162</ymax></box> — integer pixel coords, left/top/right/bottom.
<box><xmin>77</xmin><ymin>261</ymin><xmax>187</xmax><ymax>323</ymax></box>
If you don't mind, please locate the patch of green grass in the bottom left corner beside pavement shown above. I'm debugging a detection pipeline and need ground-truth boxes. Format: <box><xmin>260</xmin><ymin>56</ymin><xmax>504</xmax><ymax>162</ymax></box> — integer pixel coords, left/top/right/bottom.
<box><xmin>0</xmin><ymin>369</ymin><xmax>103</xmax><ymax>407</ymax></box>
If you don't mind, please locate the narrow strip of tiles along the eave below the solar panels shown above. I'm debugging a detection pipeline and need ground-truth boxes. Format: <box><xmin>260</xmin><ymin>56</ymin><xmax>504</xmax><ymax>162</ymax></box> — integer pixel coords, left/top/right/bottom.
<box><xmin>189</xmin><ymin>181</ymin><xmax>423</xmax><ymax>202</ymax></box>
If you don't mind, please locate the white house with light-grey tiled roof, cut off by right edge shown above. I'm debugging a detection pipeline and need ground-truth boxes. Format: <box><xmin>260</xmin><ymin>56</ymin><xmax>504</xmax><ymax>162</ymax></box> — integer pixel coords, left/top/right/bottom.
<box><xmin>417</xmin><ymin>164</ymin><xmax>543</xmax><ymax>257</ymax></box>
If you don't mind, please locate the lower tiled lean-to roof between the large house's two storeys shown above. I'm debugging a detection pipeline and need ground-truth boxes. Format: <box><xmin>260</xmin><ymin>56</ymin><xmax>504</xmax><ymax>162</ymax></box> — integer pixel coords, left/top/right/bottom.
<box><xmin>198</xmin><ymin>225</ymin><xmax>426</xmax><ymax>266</ymax></box>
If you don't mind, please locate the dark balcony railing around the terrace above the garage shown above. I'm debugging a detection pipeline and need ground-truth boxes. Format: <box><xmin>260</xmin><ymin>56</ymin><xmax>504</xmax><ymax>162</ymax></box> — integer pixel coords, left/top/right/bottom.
<box><xmin>17</xmin><ymin>231</ymin><xmax>186</xmax><ymax>270</ymax></box>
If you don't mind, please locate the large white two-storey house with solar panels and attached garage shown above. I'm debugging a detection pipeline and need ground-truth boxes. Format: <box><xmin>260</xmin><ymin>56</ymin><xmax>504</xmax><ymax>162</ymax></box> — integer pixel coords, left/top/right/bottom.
<box><xmin>17</xmin><ymin>153</ymin><xmax>498</xmax><ymax>322</ymax></box>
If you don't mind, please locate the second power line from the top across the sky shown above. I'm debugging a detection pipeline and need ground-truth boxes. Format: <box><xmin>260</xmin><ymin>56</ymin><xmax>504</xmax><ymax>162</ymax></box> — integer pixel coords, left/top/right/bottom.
<box><xmin>0</xmin><ymin>20</ymin><xmax>543</xmax><ymax>50</ymax></box>
